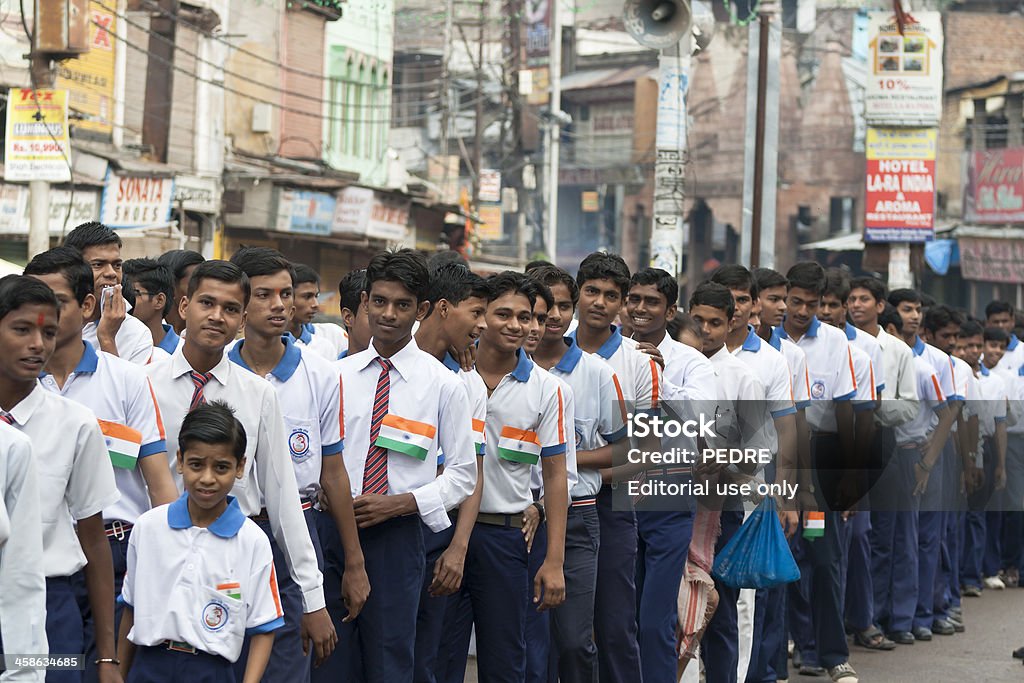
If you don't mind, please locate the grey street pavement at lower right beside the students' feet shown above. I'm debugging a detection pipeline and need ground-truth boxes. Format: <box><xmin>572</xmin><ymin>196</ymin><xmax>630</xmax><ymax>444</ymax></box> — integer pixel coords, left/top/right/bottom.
<box><xmin>466</xmin><ymin>588</ymin><xmax>1024</xmax><ymax>683</ymax></box>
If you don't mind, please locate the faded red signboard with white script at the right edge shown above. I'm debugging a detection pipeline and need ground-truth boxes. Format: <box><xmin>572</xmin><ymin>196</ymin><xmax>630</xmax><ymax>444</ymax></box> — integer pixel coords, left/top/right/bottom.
<box><xmin>964</xmin><ymin>147</ymin><xmax>1024</xmax><ymax>223</ymax></box>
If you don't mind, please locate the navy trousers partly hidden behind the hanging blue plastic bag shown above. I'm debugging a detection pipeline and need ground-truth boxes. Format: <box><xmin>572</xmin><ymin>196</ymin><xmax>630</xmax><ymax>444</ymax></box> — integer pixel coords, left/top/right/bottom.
<box><xmin>700</xmin><ymin>510</ymin><xmax>743</xmax><ymax>683</ymax></box>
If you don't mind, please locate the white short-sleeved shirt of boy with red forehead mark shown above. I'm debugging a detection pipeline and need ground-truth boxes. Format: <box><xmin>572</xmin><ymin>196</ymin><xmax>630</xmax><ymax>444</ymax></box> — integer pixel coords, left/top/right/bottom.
<box><xmin>3</xmin><ymin>384</ymin><xmax>121</xmax><ymax>578</ymax></box>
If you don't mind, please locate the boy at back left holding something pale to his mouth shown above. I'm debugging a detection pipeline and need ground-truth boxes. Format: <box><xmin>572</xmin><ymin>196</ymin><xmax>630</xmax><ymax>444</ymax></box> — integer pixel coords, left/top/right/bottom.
<box><xmin>63</xmin><ymin>221</ymin><xmax>153</xmax><ymax>366</ymax></box>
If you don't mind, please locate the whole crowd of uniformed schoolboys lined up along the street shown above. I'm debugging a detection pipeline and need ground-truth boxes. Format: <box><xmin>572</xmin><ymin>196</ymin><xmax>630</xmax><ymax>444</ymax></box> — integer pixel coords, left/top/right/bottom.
<box><xmin>0</xmin><ymin>223</ymin><xmax>1024</xmax><ymax>683</ymax></box>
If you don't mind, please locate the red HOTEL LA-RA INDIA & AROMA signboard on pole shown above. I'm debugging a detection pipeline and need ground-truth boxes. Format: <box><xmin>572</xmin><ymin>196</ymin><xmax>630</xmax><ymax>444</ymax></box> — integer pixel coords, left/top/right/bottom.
<box><xmin>864</xmin><ymin>159</ymin><xmax>935</xmax><ymax>242</ymax></box>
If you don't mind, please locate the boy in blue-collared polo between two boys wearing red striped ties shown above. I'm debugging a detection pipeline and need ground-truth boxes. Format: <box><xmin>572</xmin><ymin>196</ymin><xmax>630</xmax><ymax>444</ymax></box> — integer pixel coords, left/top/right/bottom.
<box><xmin>227</xmin><ymin>247</ymin><xmax>370</xmax><ymax>683</ymax></box>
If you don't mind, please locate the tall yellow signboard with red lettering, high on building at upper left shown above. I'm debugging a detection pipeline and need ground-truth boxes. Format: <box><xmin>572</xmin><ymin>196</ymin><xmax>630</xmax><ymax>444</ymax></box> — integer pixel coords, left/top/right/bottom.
<box><xmin>56</xmin><ymin>0</ymin><xmax>118</xmax><ymax>135</ymax></box>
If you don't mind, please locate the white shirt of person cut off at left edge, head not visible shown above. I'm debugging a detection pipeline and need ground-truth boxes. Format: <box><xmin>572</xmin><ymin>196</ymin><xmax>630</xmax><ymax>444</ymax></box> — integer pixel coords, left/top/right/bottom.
<box><xmin>0</xmin><ymin>422</ymin><xmax>49</xmax><ymax>683</ymax></box>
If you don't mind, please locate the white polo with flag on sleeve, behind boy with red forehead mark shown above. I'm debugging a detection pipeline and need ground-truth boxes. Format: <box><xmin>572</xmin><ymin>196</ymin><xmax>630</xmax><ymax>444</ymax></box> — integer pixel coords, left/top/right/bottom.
<box><xmin>39</xmin><ymin>342</ymin><xmax>167</xmax><ymax>523</ymax></box>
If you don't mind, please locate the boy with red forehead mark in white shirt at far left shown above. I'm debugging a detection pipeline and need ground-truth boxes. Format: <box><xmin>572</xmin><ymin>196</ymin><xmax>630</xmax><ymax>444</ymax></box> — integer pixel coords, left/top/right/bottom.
<box><xmin>0</xmin><ymin>275</ymin><xmax>120</xmax><ymax>683</ymax></box>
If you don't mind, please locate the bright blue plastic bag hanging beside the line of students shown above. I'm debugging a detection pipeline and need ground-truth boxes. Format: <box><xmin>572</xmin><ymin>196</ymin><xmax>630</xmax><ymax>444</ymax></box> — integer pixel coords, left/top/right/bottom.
<box><xmin>712</xmin><ymin>496</ymin><xmax>800</xmax><ymax>588</ymax></box>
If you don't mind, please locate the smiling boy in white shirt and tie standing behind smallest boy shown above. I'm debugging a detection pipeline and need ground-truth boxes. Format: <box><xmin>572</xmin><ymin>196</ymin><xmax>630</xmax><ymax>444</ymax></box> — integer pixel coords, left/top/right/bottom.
<box><xmin>146</xmin><ymin>260</ymin><xmax>337</xmax><ymax>663</ymax></box>
